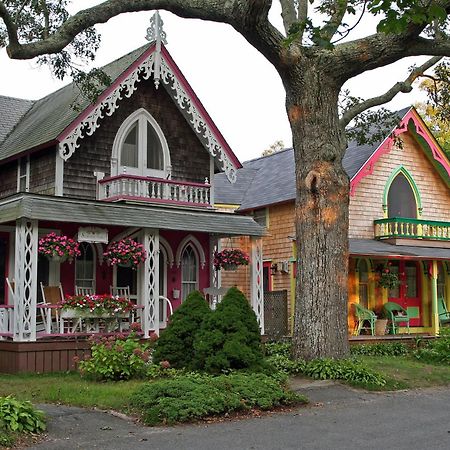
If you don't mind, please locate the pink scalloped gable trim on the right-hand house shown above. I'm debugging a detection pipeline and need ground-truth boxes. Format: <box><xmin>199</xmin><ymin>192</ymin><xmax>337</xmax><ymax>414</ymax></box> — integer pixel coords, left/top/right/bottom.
<box><xmin>350</xmin><ymin>107</ymin><xmax>450</xmax><ymax>196</ymax></box>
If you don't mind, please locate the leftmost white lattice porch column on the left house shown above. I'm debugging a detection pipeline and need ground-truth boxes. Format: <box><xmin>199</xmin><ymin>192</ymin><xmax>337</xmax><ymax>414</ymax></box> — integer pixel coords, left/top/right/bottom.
<box><xmin>13</xmin><ymin>218</ymin><xmax>38</xmax><ymax>341</ymax></box>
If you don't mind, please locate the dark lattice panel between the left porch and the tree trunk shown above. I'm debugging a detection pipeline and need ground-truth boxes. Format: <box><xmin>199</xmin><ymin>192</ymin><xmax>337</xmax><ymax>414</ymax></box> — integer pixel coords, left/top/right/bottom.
<box><xmin>264</xmin><ymin>290</ymin><xmax>288</xmax><ymax>340</ymax></box>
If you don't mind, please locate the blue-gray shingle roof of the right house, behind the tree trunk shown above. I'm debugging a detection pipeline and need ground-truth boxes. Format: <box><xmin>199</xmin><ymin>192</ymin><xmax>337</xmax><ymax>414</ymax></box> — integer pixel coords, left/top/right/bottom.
<box><xmin>214</xmin><ymin>107</ymin><xmax>411</xmax><ymax>210</ymax></box>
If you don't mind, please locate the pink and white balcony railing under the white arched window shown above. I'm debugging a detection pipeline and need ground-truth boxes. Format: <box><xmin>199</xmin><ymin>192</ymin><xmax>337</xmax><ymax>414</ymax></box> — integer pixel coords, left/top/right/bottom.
<box><xmin>98</xmin><ymin>174</ymin><xmax>211</xmax><ymax>207</ymax></box>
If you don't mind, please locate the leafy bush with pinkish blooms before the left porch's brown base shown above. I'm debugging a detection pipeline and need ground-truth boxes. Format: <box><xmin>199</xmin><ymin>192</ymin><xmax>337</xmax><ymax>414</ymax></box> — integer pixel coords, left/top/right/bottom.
<box><xmin>75</xmin><ymin>333</ymin><xmax>151</xmax><ymax>381</ymax></box>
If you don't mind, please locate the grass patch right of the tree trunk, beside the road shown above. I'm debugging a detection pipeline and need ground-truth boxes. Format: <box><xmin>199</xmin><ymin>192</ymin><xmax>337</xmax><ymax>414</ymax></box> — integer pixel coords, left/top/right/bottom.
<box><xmin>359</xmin><ymin>356</ymin><xmax>450</xmax><ymax>390</ymax></box>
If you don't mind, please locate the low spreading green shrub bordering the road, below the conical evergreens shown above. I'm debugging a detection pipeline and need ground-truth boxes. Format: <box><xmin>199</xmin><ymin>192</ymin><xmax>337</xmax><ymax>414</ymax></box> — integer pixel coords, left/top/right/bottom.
<box><xmin>131</xmin><ymin>374</ymin><xmax>306</xmax><ymax>425</ymax></box>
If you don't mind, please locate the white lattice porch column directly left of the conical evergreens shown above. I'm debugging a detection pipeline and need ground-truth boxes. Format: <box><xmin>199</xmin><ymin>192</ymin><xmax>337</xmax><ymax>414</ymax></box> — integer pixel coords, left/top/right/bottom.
<box><xmin>141</xmin><ymin>228</ymin><xmax>159</xmax><ymax>338</ymax></box>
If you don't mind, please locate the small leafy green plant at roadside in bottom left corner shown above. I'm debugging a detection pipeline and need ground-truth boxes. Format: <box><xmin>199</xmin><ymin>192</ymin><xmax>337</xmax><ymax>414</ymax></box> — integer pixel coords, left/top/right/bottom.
<box><xmin>0</xmin><ymin>396</ymin><xmax>46</xmax><ymax>433</ymax></box>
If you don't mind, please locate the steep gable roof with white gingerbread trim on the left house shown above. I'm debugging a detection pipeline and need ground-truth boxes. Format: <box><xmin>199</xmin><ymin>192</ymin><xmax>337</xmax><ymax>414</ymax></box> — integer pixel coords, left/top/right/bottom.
<box><xmin>0</xmin><ymin>43</ymin><xmax>242</xmax><ymax>181</ymax></box>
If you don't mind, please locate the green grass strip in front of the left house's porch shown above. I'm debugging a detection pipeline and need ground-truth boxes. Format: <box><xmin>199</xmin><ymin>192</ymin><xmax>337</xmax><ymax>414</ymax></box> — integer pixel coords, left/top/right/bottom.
<box><xmin>0</xmin><ymin>373</ymin><xmax>145</xmax><ymax>411</ymax></box>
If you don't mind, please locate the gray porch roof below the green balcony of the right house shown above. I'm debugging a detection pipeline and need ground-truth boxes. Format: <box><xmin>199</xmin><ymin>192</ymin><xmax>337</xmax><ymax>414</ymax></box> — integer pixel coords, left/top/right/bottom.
<box><xmin>349</xmin><ymin>239</ymin><xmax>450</xmax><ymax>260</ymax></box>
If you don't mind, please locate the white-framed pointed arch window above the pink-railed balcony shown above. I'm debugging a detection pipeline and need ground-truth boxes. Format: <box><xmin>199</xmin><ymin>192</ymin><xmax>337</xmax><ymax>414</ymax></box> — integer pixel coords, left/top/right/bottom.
<box><xmin>111</xmin><ymin>108</ymin><xmax>170</xmax><ymax>178</ymax></box>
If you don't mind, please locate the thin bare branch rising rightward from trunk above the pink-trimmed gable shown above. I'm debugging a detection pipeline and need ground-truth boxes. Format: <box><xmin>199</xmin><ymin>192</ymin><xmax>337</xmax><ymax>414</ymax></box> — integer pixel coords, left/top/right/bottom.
<box><xmin>339</xmin><ymin>56</ymin><xmax>442</xmax><ymax>128</ymax></box>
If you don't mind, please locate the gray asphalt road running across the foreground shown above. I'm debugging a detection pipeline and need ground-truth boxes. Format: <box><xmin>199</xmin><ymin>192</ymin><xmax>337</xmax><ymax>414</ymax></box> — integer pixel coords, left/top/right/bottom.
<box><xmin>32</xmin><ymin>383</ymin><xmax>450</xmax><ymax>450</ymax></box>
